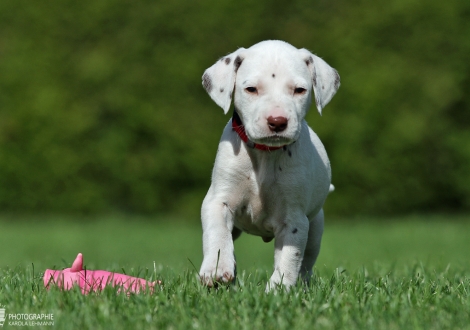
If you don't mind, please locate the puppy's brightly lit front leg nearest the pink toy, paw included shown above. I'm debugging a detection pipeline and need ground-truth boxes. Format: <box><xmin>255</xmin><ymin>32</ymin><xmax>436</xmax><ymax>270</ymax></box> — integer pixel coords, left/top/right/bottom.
<box><xmin>199</xmin><ymin>197</ymin><xmax>235</xmax><ymax>286</ymax></box>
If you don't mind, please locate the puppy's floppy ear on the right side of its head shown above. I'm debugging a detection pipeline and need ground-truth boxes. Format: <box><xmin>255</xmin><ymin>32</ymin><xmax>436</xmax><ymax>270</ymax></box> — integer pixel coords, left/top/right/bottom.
<box><xmin>300</xmin><ymin>49</ymin><xmax>340</xmax><ymax>114</ymax></box>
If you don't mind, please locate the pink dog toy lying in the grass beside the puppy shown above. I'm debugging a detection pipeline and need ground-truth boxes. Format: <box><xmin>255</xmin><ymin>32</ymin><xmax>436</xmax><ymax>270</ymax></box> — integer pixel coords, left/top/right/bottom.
<box><xmin>44</xmin><ymin>253</ymin><xmax>156</xmax><ymax>294</ymax></box>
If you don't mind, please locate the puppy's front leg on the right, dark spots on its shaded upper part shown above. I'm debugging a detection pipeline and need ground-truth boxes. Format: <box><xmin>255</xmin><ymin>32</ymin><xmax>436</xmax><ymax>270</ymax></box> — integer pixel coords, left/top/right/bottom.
<box><xmin>266</xmin><ymin>215</ymin><xmax>309</xmax><ymax>291</ymax></box>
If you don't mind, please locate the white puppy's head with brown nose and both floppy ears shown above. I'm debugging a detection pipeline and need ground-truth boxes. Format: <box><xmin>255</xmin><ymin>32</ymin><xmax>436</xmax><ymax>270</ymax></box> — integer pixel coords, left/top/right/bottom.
<box><xmin>202</xmin><ymin>41</ymin><xmax>340</xmax><ymax>146</ymax></box>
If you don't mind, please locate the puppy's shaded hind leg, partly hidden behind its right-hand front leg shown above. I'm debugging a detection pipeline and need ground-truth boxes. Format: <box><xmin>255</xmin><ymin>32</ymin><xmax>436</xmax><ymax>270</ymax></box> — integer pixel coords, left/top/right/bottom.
<box><xmin>300</xmin><ymin>209</ymin><xmax>324</xmax><ymax>282</ymax></box>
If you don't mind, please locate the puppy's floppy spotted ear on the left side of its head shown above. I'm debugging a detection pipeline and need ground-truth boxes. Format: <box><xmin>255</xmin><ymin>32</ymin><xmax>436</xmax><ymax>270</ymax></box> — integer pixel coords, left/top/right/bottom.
<box><xmin>202</xmin><ymin>48</ymin><xmax>245</xmax><ymax>113</ymax></box>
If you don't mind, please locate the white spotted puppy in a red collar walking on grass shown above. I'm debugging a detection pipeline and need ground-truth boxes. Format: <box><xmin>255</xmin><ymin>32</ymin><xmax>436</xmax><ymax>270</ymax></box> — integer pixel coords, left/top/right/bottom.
<box><xmin>199</xmin><ymin>41</ymin><xmax>340</xmax><ymax>290</ymax></box>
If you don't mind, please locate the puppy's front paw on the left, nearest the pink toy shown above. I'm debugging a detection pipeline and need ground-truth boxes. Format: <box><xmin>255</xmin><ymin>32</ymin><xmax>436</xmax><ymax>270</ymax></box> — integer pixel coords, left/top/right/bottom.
<box><xmin>199</xmin><ymin>258</ymin><xmax>236</xmax><ymax>287</ymax></box>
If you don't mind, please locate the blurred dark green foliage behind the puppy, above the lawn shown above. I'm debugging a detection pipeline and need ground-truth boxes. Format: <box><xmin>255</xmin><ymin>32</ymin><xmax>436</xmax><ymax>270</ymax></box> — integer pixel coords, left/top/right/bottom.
<box><xmin>0</xmin><ymin>0</ymin><xmax>470</xmax><ymax>215</ymax></box>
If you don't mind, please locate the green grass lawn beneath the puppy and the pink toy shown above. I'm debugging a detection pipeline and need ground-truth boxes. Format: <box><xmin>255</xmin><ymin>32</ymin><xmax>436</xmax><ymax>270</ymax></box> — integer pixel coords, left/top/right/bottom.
<box><xmin>0</xmin><ymin>216</ymin><xmax>470</xmax><ymax>329</ymax></box>
